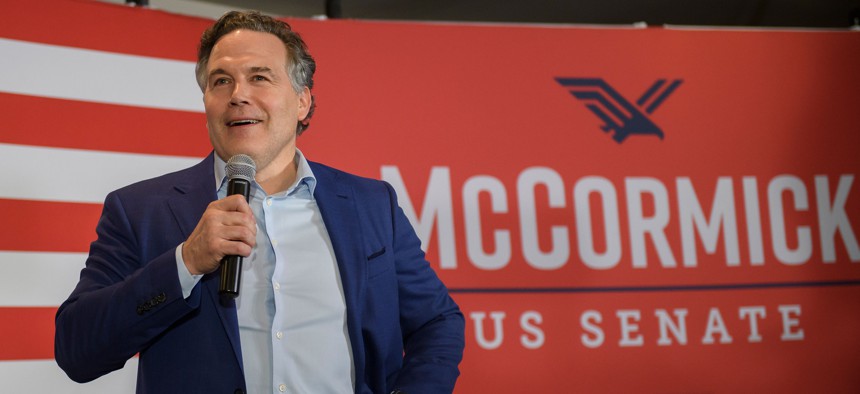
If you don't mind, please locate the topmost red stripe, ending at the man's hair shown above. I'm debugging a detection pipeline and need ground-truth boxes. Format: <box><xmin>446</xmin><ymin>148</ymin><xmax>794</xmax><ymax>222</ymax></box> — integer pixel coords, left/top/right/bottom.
<box><xmin>0</xmin><ymin>0</ymin><xmax>212</xmax><ymax>61</ymax></box>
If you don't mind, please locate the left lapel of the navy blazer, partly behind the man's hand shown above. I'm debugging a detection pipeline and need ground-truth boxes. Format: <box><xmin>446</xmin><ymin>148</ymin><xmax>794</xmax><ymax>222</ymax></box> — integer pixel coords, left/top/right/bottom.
<box><xmin>168</xmin><ymin>153</ymin><xmax>242</xmax><ymax>367</ymax></box>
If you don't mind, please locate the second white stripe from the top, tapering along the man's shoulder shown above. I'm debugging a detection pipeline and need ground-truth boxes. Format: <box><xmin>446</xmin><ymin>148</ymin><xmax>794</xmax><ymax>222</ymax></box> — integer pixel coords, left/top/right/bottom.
<box><xmin>0</xmin><ymin>144</ymin><xmax>200</xmax><ymax>204</ymax></box>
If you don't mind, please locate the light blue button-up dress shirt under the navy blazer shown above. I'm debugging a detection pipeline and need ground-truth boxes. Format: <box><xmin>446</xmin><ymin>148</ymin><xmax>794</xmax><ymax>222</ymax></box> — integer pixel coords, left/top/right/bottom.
<box><xmin>176</xmin><ymin>150</ymin><xmax>355</xmax><ymax>394</ymax></box>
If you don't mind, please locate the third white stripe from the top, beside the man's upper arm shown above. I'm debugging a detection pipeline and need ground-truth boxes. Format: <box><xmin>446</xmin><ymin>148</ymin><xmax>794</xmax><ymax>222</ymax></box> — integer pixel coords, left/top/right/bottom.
<box><xmin>0</xmin><ymin>251</ymin><xmax>87</xmax><ymax>307</ymax></box>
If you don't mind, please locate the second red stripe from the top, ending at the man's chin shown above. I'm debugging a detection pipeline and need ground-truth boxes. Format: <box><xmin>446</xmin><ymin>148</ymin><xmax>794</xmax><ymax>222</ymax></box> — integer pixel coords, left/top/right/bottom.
<box><xmin>0</xmin><ymin>93</ymin><xmax>211</xmax><ymax>157</ymax></box>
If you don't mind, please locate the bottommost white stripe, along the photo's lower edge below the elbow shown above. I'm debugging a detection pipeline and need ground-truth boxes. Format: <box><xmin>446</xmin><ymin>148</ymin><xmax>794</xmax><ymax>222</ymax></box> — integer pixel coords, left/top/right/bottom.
<box><xmin>0</xmin><ymin>358</ymin><xmax>138</xmax><ymax>394</ymax></box>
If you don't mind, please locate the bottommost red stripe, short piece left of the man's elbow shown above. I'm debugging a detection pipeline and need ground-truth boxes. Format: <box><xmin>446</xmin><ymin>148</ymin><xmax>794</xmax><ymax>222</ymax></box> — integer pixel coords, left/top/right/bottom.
<box><xmin>0</xmin><ymin>307</ymin><xmax>57</xmax><ymax>361</ymax></box>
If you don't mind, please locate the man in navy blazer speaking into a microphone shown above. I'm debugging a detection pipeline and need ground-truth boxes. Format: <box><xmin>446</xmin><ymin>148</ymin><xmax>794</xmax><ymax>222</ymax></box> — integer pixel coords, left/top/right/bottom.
<box><xmin>55</xmin><ymin>12</ymin><xmax>464</xmax><ymax>394</ymax></box>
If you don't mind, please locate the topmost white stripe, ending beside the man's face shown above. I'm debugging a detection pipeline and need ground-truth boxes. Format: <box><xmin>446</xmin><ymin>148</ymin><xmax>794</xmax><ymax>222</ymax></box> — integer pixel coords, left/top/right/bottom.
<box><xmin>0</xmin><ymin>38</ymin><xmax>203</xmax><ymax>112</ymax></box>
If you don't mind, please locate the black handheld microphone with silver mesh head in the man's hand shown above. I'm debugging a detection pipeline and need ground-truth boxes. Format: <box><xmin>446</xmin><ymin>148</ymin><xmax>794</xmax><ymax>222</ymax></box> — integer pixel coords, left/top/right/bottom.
<box><xmin>218</xmin><ymin>154</ymin><xmax>257</xmax><ymax>298</ymax></box>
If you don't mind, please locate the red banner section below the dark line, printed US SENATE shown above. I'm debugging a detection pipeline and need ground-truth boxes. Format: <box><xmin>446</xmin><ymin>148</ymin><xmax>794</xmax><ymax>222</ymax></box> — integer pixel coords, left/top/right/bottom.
<box><xmin>457</xmin><ymin>287</ymin><xmax>860</xmax><ymax>393</ymax></box>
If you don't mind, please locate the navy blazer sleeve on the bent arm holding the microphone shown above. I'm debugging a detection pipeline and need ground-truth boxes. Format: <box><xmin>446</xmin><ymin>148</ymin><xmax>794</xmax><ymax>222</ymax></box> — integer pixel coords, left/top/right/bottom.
<box><xmin>54</xmin><ymin>192</ymin><xmax>200</xmax><ymax>382</ymax></box>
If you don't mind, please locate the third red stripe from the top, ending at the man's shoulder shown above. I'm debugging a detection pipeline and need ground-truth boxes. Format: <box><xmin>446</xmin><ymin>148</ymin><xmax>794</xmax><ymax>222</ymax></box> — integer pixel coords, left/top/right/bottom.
<box><xmin>0</xmin><ymin>199</ymin><xmax>102</xmax><ymax>254</ymax></box>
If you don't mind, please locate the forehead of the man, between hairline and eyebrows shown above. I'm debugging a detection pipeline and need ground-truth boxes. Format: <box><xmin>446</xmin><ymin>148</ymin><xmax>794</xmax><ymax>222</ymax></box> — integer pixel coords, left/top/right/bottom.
<box><xmin>208</xmin><ymin>30</ymin><xmax>287</xmax><ymax>70</ymax></box>
